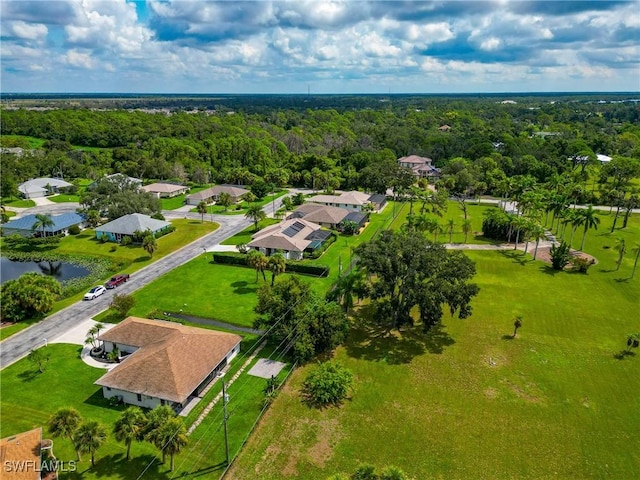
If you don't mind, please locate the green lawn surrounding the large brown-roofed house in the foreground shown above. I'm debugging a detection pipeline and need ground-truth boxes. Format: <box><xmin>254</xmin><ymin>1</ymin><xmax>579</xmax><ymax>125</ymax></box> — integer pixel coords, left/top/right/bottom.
<box><xmin>0</xmin><ymin>336</ymin><xmax>288</xmax><ymax>480</ymax></box>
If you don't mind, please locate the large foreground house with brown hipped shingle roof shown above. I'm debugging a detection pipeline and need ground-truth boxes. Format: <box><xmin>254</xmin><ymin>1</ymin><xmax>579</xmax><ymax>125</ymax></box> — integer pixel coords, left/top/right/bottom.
<box><xmin>95</xmin><ymin>317</ymin><xmax>242</xmax><ymax>411</ymax></box>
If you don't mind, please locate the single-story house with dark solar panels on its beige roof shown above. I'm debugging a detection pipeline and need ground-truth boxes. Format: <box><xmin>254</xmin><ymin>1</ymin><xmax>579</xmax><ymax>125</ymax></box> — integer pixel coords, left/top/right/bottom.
<box><xmin>247</xmin><ymin>218</ymin><xmax>331</xmax><ymax>260</ymax></box>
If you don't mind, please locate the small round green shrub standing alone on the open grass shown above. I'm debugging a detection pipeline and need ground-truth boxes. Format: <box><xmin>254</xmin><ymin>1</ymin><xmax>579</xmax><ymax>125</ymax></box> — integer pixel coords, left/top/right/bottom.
<box><xmin>302</xmin><ymin>361</ymin><xmax>353</xmax><ymax>406</ymax></box>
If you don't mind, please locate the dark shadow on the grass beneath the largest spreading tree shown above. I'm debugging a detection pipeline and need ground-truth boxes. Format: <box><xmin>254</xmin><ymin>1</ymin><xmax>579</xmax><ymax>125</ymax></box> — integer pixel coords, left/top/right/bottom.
<box><xmin>345</xmin><ymin>305</ymin><xmax>455</xmax><ymax>365</ymax></box>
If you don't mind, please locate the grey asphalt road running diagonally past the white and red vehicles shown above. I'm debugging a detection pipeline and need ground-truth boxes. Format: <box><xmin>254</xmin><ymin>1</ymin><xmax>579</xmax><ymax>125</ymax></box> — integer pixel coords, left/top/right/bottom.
<box><xmin>0</xmin><ymin>193</ymin><xmax>290</xmax><ymax>369</ymax></box>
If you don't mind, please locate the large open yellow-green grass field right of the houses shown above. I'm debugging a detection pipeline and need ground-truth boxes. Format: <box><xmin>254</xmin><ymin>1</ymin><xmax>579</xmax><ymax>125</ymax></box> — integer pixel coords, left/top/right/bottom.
<box><xmin>228</xmin><ymin>246</ymin><xmax>640</xmax><ymax>479</ymax></box>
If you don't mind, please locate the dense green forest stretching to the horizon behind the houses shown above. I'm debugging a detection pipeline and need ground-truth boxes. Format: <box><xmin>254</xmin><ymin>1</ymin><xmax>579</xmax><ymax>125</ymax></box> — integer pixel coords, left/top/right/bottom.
<box><xmin>1</xmin><ymin>94</ymin><xmax>640</xmax><ymax>202</ymax></box>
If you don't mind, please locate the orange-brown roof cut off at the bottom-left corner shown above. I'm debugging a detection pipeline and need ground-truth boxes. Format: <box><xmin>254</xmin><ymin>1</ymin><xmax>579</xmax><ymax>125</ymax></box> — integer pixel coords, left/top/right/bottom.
<box><xmin>0</xmin><ymin>428</ymin><xmax>47</xmax><ymax>480</ymax></box>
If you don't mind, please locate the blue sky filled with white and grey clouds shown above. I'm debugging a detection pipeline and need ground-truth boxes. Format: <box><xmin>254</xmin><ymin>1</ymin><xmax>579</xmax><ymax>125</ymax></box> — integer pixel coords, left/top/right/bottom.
<box><xmin>0</xmin><ymin>0</ymin><xmax>640</xmax><ymax>93</ymax></box>
